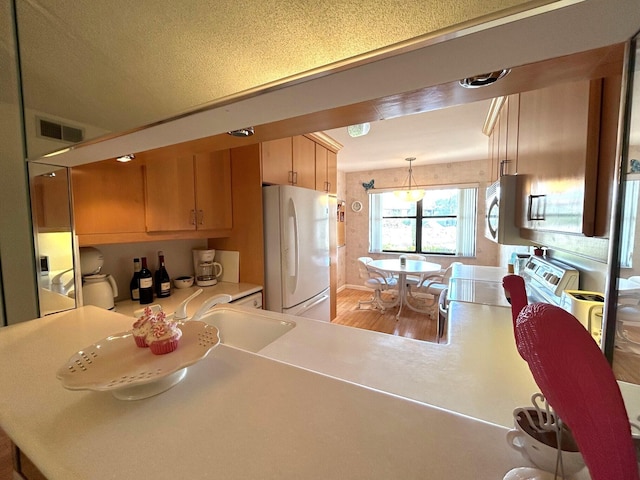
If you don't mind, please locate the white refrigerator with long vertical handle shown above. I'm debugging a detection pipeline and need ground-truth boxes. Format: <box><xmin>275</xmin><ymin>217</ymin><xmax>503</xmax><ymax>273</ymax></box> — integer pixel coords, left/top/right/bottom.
<box><xmin>262</xmin><ymin>185</ymin><xmax>331</xmax><ymax>322</ymax></box>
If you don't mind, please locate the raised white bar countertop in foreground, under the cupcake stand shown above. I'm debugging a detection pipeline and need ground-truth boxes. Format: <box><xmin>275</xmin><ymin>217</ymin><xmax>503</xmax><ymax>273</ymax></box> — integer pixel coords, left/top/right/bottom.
<box><xmin>0</xmin><ymin>306</ymin><xmax>524</xmax><ymax>480</ymax></box>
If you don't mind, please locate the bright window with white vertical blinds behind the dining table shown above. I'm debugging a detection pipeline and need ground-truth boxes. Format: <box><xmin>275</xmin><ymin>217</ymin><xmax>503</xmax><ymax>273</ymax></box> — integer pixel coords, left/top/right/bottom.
<box><xmin>369</xmin><ymin>187</ymin><xmax>478</xmax><ymax>257</ymax></box>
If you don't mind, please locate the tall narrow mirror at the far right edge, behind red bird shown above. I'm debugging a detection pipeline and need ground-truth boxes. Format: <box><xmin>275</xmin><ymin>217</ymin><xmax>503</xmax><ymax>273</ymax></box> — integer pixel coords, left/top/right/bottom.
<box><xmin>605</xmin><ymin>38</ymin><xmax>640</xmax><ymax>384</ymax></box>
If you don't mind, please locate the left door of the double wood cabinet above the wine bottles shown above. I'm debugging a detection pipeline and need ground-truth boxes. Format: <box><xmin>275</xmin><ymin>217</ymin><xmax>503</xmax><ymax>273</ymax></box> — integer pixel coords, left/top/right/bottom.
<box><xmin>145</xmin><ymin>154</ymin><xmax>196</xmax><ymax>232</ymax></box>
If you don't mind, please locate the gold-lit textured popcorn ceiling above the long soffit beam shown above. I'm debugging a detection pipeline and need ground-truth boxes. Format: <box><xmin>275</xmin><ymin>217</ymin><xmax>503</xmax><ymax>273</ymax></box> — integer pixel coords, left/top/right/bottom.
<box><xmin>17</xmin><ymin>0</ymin><xmax>536</xmax><ymax>132</ymax></box>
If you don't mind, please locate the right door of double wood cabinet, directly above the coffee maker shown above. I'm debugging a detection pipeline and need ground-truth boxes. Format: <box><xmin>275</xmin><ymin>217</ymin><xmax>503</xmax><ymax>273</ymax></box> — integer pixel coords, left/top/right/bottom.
<box><xmin>195</xmin><ymin>150</ymin><xmax>233</xmax><ymax>230</ymax></box>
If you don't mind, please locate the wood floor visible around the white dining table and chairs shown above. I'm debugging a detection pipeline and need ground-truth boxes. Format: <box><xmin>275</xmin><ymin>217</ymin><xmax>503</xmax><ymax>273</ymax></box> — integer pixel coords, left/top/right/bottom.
<box><xmin>331</xmin><ymin>288</ymin><xmax>446</xmax><ymax>342</ymax></box>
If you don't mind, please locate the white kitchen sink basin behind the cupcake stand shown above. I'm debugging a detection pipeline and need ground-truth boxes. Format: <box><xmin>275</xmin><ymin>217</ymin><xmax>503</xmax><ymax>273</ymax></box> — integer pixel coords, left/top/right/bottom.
<box><xmin>195</xmin><ymin>304</ymin><xmax>296</xmax><ymax>352</ymax></box>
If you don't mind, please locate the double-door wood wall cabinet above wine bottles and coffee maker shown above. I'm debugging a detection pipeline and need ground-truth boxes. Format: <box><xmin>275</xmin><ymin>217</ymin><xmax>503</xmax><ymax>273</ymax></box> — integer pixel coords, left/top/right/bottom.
<box><xmin>145</xmin><ymin>150</ymin><xmax>232</xmax><ymax>232</ymax></box>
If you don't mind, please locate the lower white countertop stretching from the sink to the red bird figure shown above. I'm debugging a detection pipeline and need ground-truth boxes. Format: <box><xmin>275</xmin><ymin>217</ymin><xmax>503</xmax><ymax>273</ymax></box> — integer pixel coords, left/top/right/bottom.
<box><xmin>259</xmin><ymin>302</ymin><xmax>538</xmax><ymax>427</ymax></box>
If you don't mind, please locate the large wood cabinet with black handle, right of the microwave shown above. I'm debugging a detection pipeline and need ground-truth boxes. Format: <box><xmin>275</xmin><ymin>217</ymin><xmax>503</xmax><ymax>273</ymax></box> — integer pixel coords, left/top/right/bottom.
<box><xmin>517</xmin><ymin>79</ymin><xmax>602</xmax><ymax>236</ymax></box>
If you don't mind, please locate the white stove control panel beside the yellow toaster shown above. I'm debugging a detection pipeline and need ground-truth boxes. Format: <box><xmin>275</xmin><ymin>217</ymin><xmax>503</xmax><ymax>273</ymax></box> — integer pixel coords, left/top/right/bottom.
<box><xmin>520</xmin><ymin>256</ymin><xmax>580</xmax><ymax>306</ymax></box>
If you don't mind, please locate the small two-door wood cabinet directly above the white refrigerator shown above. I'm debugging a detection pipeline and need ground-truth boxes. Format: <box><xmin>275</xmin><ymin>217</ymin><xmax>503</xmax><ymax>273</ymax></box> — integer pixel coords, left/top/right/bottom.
<box><xmin>260</xmin><ymin>135</ymin><xmax>316</xmax><ymax>189</ymax></box>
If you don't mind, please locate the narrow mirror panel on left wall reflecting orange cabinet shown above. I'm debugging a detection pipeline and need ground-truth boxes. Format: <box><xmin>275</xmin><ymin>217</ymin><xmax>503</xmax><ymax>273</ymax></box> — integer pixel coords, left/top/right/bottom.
<box><xmin>29</xmin><ymin>163</ymin><xmax>76</xmax><ymax>317</ymax></box>
